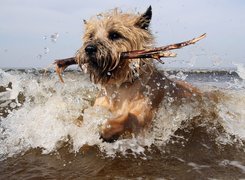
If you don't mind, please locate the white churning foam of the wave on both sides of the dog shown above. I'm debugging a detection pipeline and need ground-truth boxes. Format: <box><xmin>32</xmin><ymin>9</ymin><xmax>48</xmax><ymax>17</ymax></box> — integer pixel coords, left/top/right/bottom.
<box><xmin>0</xmin><ymin>70</ymin><xmax>245</xmax><ymax>160</ymax></box>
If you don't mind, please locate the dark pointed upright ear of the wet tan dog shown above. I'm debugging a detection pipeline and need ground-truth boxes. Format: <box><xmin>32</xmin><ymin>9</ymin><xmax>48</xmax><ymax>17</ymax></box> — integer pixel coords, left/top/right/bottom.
<box><xmin>135</xmin><ymin>6</ymin><xmax>152</xmax><ymax>30</ymax></box>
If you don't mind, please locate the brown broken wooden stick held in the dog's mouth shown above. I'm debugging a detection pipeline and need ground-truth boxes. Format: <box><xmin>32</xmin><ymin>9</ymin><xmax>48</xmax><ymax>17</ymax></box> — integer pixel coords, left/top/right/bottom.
<box><xmin>54</xmin><ymin>33</ymin><xmax>206</xmax><ymax>83</ymax></box>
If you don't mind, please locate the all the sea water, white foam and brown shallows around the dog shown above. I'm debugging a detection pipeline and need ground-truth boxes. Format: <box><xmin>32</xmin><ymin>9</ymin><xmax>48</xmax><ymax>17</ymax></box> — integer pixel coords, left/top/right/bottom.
<box><xmin>0</xmin><ymin>66</ymin><xmax>245</xmax><ymax>179</ymax></box>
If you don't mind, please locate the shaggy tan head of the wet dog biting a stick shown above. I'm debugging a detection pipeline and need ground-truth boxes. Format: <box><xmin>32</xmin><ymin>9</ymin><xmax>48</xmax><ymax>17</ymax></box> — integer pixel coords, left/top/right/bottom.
<box><xmin>76</xmin><ymin>6</ymin><xmax>153</xmax><ymax>84</ymax></box>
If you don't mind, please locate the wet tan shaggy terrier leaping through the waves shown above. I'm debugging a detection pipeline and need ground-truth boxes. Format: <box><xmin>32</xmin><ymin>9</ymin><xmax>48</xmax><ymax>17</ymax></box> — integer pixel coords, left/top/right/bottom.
<box><xmin>76</xmin><ymin>6</ymin><xmax>201</xmax><ymax>142</ymax></box>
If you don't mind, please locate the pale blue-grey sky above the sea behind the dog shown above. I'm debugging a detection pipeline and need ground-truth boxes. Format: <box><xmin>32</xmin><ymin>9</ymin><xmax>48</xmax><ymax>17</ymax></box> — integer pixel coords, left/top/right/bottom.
<box><xmin>0</xmin><ymin>0</ymin><xmax>245</xmax><ymax>69</ymax></box>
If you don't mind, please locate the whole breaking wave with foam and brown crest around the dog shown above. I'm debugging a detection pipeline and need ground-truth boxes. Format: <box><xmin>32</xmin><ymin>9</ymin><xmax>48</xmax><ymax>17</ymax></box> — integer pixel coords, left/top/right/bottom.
<box><xmin>0</xmin><ymin>70</ymin><xmax>245</xmax><ymax>159</ymax></box>
